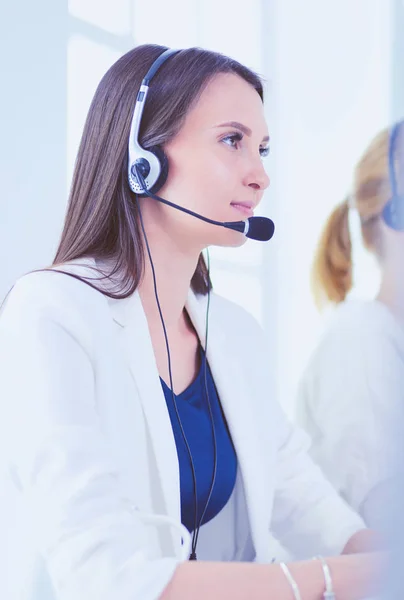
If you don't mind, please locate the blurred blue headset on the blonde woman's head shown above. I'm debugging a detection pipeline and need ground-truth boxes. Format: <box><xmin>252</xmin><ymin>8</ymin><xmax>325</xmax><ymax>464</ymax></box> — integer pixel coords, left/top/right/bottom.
<box><xmin>382</xmin><ymin>122</ymin><xmax>404</xmax><ymax>231</ymax></box>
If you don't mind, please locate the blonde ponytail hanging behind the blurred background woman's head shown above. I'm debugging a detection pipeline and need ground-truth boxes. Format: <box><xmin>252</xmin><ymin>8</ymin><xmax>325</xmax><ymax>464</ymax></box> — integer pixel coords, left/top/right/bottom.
<box><xmin>311</xmin><ymin>198</ymin><xmax>352</xmax><ymax>309</ymax></box>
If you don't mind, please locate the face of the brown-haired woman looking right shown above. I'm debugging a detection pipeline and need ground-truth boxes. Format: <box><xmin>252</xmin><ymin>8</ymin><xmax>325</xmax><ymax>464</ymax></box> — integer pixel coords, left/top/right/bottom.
<box><xmin>145</xmin><ymin>73</ymin><xmax>269</xmax><ymax>251</ymax></box>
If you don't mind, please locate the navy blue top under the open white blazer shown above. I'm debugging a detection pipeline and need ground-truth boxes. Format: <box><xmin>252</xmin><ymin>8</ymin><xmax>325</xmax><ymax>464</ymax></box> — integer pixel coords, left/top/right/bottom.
<box><xmin>160</xmin><ymin>348</ymin><xmax>237</xmax><ymax>532</ymax></box>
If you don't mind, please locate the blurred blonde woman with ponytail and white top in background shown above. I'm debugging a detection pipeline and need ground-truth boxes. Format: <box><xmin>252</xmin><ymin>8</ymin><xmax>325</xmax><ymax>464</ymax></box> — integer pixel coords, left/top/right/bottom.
<box><xmin>297</xmin><ymin>122</ymin><xmax>404</xmax><ymax>528</ymax></box>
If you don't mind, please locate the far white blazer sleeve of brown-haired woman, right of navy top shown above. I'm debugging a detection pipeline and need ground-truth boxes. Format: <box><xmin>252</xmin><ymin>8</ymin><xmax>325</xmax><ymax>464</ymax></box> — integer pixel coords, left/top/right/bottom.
<box><xmin>272</xmin><ymin>398</ymin><xmax>365</xmax><ymax>559</ymax></box>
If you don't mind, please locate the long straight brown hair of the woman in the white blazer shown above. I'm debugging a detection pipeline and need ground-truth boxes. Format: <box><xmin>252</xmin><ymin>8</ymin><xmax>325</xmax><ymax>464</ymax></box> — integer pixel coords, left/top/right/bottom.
<box><xmin>52</xmin><ymin>44</ymin><xmax>263</xmax><ymax>298</ymax></box>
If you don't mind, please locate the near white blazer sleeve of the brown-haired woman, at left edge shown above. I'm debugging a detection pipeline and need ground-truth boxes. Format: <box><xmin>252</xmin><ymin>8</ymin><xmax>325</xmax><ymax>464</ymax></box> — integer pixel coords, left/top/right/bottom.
<box><xmin>0</xmin><ymin>284</ymin><xmax>179</xmax><ymax>600</ymax></box>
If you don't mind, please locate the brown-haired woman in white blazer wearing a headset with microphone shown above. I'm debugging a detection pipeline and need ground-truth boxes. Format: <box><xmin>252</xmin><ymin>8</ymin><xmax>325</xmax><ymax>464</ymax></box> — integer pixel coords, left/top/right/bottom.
<box><xmin>0</xmin><ymin>45</ymin><xmax>380</xmax><ymax>600</ymax></box>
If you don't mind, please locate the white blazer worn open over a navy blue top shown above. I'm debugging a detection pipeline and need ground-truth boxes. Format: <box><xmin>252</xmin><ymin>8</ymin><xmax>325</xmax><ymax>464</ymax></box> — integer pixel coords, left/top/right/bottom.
<box><xmin>0</xmin><ymin>260</ymin><xmax>363</xmax><ymax>600</ymax></box>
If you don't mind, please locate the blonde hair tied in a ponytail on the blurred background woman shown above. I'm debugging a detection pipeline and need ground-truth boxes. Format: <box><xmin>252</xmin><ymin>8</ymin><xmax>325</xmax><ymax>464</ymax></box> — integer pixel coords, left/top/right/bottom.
<box><xmin>311</xmin><ymin>121</ymin><xmax>404</xmax><ymax>308</ymax></box>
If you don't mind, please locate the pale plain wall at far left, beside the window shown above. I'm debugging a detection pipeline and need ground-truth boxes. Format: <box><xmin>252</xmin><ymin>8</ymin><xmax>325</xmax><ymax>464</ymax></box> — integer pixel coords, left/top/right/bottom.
<box><xmin>0</xmin><ymin>0</ymin><xmax>67</xmax><ymax>301</ymax></box>
